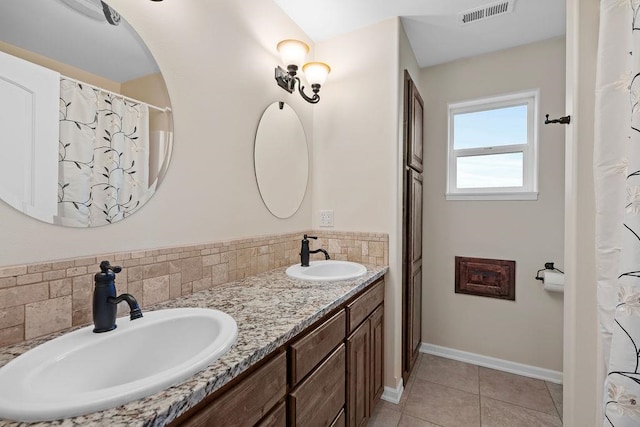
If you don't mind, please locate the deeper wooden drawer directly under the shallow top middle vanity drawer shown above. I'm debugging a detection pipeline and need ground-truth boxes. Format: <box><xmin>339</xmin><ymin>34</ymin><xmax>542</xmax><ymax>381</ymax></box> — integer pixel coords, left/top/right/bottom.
<box><xmin>289</xmin><ymin>344</ymin><xmax>346</xmax><ymax>427</ymax></box>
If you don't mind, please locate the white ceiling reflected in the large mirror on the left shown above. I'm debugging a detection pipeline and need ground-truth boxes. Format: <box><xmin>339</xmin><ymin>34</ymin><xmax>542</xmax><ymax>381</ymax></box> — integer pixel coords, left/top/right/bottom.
<box><xmin>0</xmin><ymin>0</ymin><xmax>159</xmax><ymax>83</ymax></box>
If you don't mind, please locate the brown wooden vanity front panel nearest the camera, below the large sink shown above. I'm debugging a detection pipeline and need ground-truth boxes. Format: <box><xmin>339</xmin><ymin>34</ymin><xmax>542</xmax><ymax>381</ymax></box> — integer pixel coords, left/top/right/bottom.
<box><xmin>181</xmin><ymin>353</ymin><xmax>287</xmax><ymax>427</ymax></box>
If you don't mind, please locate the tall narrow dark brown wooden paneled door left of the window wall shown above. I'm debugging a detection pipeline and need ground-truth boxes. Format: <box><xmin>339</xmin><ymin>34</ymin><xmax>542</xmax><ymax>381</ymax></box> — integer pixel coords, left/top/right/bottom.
<box><xmin>402</xmin><ymin>70</ymin><xmax>424</xmax><ymax>384</ymax></box>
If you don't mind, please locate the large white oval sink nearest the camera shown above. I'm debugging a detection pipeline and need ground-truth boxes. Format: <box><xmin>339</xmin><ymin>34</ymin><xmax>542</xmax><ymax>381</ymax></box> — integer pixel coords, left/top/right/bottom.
<box><xmin>0</xmin><ymin>308</ymin><xmax>238</xmax><ymax>422</ymax></box>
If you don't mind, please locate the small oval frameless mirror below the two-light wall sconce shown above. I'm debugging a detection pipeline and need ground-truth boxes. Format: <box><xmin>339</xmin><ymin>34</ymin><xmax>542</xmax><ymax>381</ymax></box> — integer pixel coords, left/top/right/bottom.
<box><xmin>254</xmin><ymin>102</ymin><xmax>309</xmax><ymax>218</ymax></box>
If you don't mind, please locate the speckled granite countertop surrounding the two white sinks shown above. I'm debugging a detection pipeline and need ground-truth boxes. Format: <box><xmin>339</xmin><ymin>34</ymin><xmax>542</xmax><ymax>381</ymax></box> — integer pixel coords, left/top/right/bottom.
<box><xmin>0</xmin><ymin>265</ymin><xmax>388</xmax><ymax>427</ymax></box>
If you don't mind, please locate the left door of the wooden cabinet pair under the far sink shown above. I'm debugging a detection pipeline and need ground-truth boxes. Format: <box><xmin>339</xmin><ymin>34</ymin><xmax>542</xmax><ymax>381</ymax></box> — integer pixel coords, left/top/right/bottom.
<box><xmin>347</xmin><ymin>319</ymin><xmax>371</xmax><ymax>427</ymax></box>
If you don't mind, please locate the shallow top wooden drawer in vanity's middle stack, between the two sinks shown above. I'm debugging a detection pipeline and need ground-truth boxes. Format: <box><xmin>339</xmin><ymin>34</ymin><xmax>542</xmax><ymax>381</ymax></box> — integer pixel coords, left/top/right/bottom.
<box><xmin>289</xmin><ymin>310</ymin><xmax>345</xmax><ymax>386</ymax></box>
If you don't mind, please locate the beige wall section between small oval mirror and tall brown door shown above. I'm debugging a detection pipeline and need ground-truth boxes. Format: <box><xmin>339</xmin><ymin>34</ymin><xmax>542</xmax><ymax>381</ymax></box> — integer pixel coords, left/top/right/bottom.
<box><xmin>312</xmin><ymin>19</ymin><xmax>401</xmax><ymax>387</ymax></box>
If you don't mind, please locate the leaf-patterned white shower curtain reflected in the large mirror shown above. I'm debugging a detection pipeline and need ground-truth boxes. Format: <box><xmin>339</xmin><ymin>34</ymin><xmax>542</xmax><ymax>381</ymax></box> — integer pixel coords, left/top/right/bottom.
<box><xmin>56</xmin><ymin>78</ymin><xmax>149</xmax><ymax>227</ymax></box>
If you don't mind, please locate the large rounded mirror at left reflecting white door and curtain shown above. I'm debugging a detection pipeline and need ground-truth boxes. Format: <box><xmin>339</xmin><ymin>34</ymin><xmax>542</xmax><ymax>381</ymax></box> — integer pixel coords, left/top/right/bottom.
<box><xmin>0</xmin><ymin>0</ymin><xmax>173</xmax><ymax>227</ymax></box>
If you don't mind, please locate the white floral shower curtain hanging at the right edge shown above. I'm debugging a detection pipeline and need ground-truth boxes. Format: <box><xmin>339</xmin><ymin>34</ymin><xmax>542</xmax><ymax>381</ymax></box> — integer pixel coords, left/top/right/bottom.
<box><xmin>596</xmin><ymin>0</ymin><xmax>640</xmax><ymax>427</ymax></box>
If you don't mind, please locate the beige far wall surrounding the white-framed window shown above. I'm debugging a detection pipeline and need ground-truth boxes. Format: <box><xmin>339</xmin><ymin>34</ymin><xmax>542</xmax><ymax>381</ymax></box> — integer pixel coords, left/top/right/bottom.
<box><xmin>421</xmin><ymin>38</ymin><xmax>565</xmax><ymax>371</ymax></box>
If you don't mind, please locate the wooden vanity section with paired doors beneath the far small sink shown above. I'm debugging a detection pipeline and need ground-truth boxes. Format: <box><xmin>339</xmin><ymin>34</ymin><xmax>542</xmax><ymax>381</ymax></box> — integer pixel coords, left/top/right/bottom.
<box><xmin>346</xmin><ymin>282</ymin><xmax>384</xmax><ymax>427</ymax></box>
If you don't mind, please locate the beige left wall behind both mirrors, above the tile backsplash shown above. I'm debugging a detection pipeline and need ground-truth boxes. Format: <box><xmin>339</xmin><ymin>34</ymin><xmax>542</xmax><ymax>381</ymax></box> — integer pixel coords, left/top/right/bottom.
<box><xmin>0</xmin><ymin>0</ymin><xmax>316</xmax><ymax>266</ymax></box>
